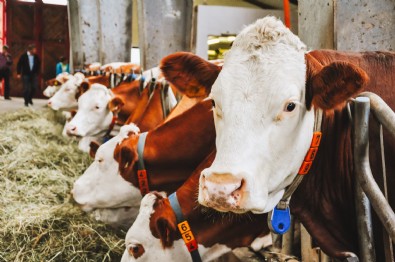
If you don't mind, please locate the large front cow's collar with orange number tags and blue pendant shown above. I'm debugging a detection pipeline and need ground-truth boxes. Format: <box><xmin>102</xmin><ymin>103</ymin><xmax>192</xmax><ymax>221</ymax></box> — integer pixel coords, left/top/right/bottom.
<box><xmin>268</xmin><ymin>109</ymin><xmax>322</xmax><ymax>235</ymax></box>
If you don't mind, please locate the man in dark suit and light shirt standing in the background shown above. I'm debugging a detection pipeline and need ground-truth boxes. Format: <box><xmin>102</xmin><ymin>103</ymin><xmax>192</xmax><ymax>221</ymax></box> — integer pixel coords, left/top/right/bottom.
<box><xmin>16</xmin><ymin>45</ymin><xmax>40</xmax><ymax>106</ymax></box>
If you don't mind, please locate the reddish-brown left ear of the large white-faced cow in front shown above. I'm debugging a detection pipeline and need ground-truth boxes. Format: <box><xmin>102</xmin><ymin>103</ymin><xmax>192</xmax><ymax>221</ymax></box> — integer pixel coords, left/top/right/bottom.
<box><xmin>160</xmin><ymin>52</ymin><xmax>221</xmax><ymax>97</ymax></box>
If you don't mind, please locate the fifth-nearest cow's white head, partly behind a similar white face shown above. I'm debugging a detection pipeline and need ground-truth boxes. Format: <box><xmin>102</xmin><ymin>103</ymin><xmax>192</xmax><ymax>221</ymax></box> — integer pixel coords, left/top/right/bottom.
<box><xmin>48</xmin><ymin>73</ymin><xmax>85</xmax><ymax>110</ymax></box>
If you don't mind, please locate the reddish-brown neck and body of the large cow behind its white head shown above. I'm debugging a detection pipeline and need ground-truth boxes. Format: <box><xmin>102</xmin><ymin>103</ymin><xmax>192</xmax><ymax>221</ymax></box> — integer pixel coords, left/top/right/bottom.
<box><xmin>290</xmin><ymin>50</ymin><xmax>395</xmax><ymax>261</ymax></box>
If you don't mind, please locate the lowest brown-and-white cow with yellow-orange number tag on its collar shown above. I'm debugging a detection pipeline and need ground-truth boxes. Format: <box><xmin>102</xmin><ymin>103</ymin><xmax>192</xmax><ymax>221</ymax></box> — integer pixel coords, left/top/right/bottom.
<box><xmin>121</xmin><ymin>151</ymin><xmax>271</xmax><ymax>262</ymax></box>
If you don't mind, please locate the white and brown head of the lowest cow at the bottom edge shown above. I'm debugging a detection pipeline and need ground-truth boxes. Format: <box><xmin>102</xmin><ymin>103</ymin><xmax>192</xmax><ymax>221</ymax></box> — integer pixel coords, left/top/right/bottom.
<box><xmin>121</xmin><ymin>192</ymin><xmax>191</xmax><ymax>262</ymax></box>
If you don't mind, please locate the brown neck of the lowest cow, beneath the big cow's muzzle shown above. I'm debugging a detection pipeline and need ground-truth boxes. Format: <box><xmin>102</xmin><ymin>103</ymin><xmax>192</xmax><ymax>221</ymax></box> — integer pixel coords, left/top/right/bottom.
<box><xmin>172</xmin><ymin>151</ymin><xmax>269</xmax><ymax>251</ymax></box>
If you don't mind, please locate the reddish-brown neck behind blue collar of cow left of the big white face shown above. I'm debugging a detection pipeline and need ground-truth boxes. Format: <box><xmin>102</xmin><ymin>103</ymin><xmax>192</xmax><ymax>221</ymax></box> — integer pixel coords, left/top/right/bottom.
<box><xmin>127</xmin><ymin>101</ymin><xmax>215</xmax><ymax>192</ymax></box>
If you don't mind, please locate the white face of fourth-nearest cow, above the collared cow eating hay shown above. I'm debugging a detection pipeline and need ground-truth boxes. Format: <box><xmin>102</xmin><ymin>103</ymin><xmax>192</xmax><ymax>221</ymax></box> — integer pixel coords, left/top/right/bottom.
<box><xmin>66</xmin><ymin>84</ymin><xmax>123</xmax><ymax>137</ymax></box>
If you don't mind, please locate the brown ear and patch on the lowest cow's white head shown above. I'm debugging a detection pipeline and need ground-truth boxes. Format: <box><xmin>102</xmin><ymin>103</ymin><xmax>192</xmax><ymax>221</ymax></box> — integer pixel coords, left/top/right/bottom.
<box><xmin>149</xmin><ymin>192</ymin><xmax>178</xmax><ymax>248</ymax></box>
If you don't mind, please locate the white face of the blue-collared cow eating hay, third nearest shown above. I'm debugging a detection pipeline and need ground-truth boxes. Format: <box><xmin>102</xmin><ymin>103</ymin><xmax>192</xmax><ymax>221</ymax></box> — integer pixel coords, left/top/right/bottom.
<box><xmin>72</xmin><ymin>125</ymin><xmax>141</xmax><ymax>211</ymax></box>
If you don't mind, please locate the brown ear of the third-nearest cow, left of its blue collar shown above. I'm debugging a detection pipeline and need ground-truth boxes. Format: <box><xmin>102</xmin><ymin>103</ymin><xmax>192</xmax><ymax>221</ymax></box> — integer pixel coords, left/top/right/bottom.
<box><xmin>114</xmin><ymin>134</ymin><xmax>139</xmax><ymax>181</ymax></box>
